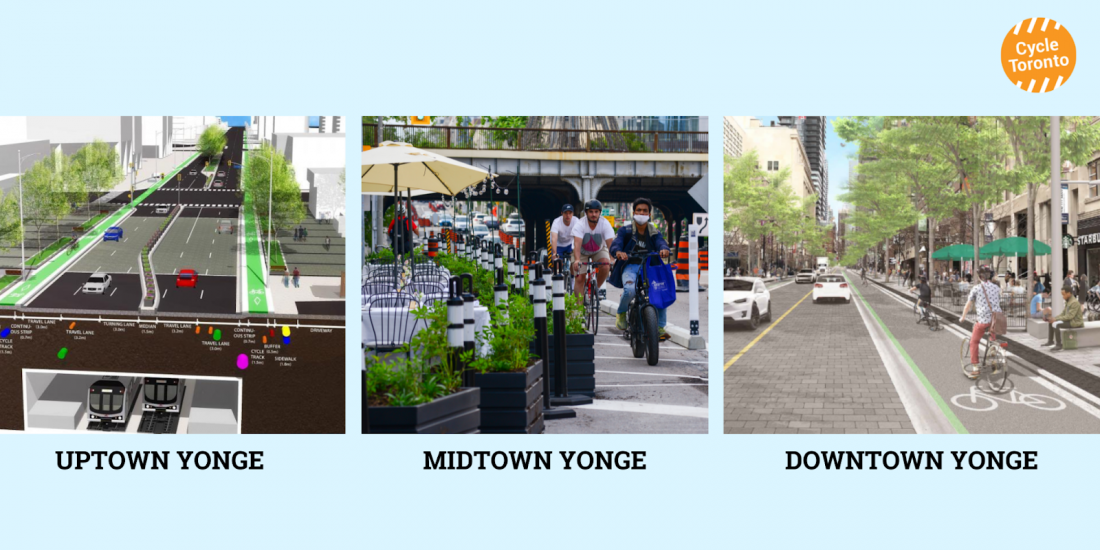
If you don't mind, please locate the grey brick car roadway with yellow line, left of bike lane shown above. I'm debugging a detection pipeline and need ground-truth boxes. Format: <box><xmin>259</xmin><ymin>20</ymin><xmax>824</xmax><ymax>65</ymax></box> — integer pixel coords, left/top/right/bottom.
<box><xmin>723</xmin><ymin>275</ymin><xmax>914</xmax><ymax>433</ymax></box>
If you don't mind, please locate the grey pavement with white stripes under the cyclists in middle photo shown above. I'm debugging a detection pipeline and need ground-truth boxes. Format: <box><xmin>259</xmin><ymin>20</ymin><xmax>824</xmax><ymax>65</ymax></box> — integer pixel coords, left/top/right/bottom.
<box><xmin>546</xmin><ymin>279</ymin><xmax>710</xmax><ymax>433</ymax></box>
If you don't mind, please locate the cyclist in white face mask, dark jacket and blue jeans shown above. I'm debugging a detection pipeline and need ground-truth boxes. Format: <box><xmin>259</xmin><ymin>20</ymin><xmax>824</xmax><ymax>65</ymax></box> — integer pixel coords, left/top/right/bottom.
<box><xmin>611</xmin><ymin>198</ymin><xmax>669</xmax><ymax>340</ymax></box>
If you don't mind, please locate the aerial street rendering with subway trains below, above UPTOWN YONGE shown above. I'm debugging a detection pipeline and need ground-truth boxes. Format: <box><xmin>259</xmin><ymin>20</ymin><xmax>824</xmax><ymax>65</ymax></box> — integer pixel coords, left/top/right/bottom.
<box><xmin>0</xmin><ymin>117</ymin><xmax>345</xmax><ymax>433</ymax></box>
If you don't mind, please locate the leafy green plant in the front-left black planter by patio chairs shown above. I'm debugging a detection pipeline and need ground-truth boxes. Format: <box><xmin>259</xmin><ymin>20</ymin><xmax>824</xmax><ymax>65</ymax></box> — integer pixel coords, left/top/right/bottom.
<box><xmin>366</xmin><ymin>301</ymin><xmax>462</xmax><ymax>407</ymax></box>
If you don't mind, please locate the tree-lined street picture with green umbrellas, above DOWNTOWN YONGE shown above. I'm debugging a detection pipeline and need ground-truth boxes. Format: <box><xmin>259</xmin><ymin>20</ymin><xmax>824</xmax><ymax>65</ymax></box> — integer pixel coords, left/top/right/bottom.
<box><xmin>723</xmin><ymin>117</ymin><xmax>1100</xmax><ymax>433</ymax></box>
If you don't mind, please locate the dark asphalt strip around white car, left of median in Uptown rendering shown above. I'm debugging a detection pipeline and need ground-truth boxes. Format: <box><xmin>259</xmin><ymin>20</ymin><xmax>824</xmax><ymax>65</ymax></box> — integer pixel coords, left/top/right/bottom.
<box><xmin>26</xmin><ymin>273</ymin><xmax>141</xmax><ymax>311</ymax></box>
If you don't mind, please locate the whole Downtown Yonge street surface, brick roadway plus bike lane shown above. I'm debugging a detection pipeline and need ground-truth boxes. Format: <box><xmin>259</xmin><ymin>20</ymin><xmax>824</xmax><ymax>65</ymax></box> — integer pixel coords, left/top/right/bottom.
<box><xmin>723</xmin><ymin>267</ymin><xmax>1100</xmax><ymax>433</ymax></box>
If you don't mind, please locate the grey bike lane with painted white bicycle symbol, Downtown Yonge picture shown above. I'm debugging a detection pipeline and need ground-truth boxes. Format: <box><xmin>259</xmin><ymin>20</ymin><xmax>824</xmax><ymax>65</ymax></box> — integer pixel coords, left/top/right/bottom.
<box><xmin>847</xmin><ymin>273</ymin><xmax>1100</xmax><ymax>433</ymax></box>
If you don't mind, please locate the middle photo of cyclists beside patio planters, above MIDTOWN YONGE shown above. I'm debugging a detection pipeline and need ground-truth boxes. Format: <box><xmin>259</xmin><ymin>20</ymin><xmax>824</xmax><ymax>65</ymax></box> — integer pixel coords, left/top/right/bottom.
<box><xmin>361</xmin><ymin>117</ymin><xmax>708</xmax><ymax>433</ymax></box>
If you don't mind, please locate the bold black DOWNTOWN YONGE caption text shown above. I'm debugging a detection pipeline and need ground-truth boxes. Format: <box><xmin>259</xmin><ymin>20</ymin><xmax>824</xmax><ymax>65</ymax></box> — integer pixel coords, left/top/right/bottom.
<box><xmin>785</xmin><ymin>451</ymin><xmax>1038</xmax><ymax>470</ymax></box>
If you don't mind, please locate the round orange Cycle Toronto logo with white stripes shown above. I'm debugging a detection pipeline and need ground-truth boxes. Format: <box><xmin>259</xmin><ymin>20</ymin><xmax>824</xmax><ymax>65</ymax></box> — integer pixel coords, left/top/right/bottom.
<box><xmin>1001</xmin><ymin>18</ymin><xmax>1077</xmax><ymax>94</ymax></box>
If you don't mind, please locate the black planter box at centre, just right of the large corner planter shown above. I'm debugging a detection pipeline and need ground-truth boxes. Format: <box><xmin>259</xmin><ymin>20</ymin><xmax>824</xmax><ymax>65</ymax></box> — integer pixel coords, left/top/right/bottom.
<box><xmin>474</xmin><ymin>360</ymin><xmax>542</xmax><ymax>433</ymax></box>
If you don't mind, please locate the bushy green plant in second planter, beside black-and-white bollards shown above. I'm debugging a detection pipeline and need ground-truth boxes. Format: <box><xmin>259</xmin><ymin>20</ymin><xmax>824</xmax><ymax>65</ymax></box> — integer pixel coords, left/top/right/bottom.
<box><xmin>470</xmin><ymin>295</ymin><xmax>535</xmax><ymax>374</ymax></box>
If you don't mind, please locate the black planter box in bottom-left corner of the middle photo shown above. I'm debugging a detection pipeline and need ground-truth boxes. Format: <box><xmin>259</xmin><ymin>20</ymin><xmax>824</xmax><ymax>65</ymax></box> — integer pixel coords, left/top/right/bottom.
<box><xmin>370</xmin><ymin>387</ymin><xmax>481</xmax><ymax>433</ymax></box>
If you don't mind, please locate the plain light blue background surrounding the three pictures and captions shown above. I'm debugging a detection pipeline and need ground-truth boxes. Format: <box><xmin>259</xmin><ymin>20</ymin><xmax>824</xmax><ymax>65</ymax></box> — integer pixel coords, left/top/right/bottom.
<box><xmin>0</xmin><ymin>0</ymin><xmax>1100</xmax><ymax>548</ymax></box>
